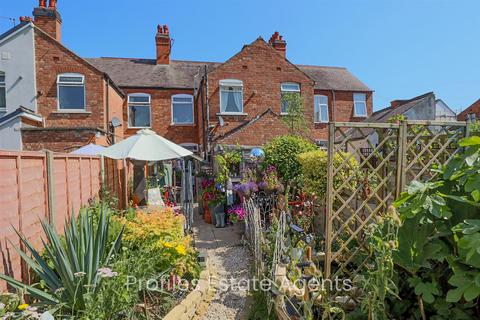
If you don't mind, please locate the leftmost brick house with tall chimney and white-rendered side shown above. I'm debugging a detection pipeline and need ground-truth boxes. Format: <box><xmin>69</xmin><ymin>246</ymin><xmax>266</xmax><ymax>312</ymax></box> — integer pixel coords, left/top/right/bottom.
<box><xmin>0</xmin><ymin>0</ymin><xmax>124</xmax><ymax>152</ymax></box>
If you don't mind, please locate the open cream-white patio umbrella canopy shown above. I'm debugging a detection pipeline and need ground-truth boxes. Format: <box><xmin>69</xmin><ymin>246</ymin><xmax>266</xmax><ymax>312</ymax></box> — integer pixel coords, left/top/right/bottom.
<box><xmin>101</xmin><ymin>129</ymin><xmax>193</xmax><ymax>161</ymax></box>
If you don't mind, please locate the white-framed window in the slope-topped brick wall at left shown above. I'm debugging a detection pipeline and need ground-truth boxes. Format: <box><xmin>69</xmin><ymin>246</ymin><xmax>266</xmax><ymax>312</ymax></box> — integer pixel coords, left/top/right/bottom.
<box><xmin>57</xmin><ymin>73</ymin><xmax>85</xmax><ymax>111</ymax></box>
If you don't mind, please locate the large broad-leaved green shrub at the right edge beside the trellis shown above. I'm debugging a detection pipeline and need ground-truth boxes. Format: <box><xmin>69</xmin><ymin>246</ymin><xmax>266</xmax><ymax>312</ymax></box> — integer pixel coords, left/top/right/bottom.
<box><xmin>388</xmin><ymin>136</ymin><xmax>480</xmax><ymax>319</ymax></box>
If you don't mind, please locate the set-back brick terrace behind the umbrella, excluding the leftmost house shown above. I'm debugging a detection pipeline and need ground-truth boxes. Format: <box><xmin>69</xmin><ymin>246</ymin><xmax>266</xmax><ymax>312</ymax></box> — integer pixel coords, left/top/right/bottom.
<box><xmin>91</xmin><ymin>26</ymin><xmax>373</xmax><ymax>153</ymax></box>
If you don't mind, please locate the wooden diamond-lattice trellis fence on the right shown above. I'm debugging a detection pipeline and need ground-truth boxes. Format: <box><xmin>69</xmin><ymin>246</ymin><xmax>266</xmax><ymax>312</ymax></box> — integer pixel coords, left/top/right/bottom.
<box><xmin>325</xmin><ymin>121</ymin><xmax>468</xmax><ymax>290</ymax></box>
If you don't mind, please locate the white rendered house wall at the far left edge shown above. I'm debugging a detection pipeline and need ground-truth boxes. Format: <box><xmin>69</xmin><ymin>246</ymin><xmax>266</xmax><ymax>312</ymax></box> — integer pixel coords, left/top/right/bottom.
<box><xmin>0</xmin><ymin>24</ymin><xmax>37</xmax><ymax>117</ymax></box>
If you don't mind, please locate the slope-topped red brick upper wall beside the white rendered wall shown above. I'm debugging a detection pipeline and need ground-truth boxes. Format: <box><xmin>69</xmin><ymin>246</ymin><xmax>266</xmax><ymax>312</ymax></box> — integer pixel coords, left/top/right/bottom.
<box><xmin>35</xmin><ymin>30</ymin><xmax>105</xmax><ymax>128</ymax></box>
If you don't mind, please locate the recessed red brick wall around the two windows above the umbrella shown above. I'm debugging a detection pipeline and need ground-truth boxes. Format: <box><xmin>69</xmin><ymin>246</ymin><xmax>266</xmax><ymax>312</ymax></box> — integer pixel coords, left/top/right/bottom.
<box><xmin>123</xmin><ymin>88</ymin><xmax>199</xmax><ymax>143</ymax></box>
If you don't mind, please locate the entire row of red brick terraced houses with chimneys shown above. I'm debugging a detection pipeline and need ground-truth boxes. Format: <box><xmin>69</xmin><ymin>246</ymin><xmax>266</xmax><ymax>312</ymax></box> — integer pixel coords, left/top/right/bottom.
<box><xmin>0</xmin><ymin>0</ymin><xmax>373</xmax><ymax>155</ymax></box>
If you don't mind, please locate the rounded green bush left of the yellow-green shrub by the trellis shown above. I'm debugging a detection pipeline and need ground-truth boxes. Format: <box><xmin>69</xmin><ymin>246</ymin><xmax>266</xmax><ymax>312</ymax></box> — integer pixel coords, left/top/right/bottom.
<box><xmin>264</xmin><ymin>135</ymin><xmax>317</xmax><ymax>183</ymax></box>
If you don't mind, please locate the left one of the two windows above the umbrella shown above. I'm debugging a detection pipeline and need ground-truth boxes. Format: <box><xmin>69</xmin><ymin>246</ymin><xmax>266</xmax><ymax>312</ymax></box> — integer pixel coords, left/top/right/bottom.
<box><xmin>128</xmin><ymin>93</ymin><xmax>151</xmax><ymax>128</ymax></box>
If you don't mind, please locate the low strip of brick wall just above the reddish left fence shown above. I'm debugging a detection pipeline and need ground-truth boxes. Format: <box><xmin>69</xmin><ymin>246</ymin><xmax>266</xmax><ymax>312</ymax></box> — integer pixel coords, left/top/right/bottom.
<box><xmin>22</xmin><ymin>129</ymin><xmax>98</xmax><ymax>152</ymax></box>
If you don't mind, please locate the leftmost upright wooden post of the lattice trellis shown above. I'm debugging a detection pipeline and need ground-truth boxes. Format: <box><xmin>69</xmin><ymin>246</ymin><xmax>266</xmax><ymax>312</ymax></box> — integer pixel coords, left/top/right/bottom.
<box><xmin>325</xmin><ymin>122</ymin><xmax>335</xmax><ymax>278</ymax></box>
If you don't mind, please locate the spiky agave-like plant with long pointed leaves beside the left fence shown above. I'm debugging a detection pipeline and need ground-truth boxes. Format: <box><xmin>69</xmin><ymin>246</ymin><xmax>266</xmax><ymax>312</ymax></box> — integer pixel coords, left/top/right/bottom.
<box><xmin>0</xmin><ymin>206</ymin><xmax>124</xmax><ymax>312</ymax></box>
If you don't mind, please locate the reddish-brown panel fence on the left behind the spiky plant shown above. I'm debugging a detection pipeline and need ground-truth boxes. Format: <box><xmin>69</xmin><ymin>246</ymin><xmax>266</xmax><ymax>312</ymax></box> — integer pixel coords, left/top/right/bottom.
<box><xmin>0</xmin><ymin>151</ymin><xmax>126</xmax><ymax>290</ymax></box>
